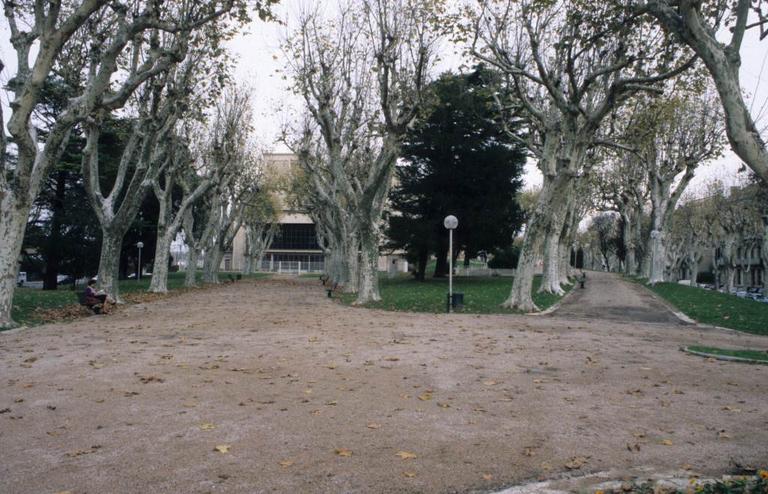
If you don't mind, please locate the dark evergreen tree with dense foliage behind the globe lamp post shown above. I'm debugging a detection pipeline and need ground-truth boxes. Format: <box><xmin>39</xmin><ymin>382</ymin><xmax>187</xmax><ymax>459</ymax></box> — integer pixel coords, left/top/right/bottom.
<box><xmin>387</xmin><ymin>67</ymin><xmax>525</xmax><ymax>280</ymax></box>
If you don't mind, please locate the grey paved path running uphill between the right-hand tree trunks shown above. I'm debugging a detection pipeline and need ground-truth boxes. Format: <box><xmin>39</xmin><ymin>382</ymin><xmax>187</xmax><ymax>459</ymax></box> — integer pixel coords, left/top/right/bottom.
<box><xmin>552</xmin><ymin>271</ymin><xmax>685</xmax><ymax>324</ymax></box>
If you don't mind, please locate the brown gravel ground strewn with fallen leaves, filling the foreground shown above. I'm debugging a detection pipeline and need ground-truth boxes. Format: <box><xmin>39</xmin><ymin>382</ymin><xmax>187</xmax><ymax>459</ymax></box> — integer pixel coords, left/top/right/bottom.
<box><xmin>0</xmin><ymin>274</ymin><xmax>768</xmax><ymax>494</ymax></box>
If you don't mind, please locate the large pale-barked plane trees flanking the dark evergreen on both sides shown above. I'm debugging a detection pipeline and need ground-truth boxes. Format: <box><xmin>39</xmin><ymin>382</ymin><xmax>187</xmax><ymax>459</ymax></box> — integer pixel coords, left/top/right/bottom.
<box><xmin>285</xmin><ymin>0</ymin><xmax>768</xmax><ymax>311</ymax></box>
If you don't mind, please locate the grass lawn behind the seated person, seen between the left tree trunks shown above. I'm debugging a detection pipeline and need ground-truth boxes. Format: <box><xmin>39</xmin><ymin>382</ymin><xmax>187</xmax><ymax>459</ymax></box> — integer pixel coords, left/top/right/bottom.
<box><xmin>6</xmin><ymin>271</ymin><xmax>267</xmax><ymax>326</ymax></box>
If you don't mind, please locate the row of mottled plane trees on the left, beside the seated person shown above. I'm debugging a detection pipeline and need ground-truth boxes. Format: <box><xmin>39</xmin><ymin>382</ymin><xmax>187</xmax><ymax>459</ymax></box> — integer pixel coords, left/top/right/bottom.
<box><xmin>0</xmin><ymin>0</ymin><xmax>274</xmax><ymax>327</ymax></box>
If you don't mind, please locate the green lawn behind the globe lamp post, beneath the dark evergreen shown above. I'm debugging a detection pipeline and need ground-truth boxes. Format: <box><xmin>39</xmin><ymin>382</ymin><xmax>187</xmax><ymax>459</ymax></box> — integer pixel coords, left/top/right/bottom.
<box><xmin>340</xmin><ymin>275</ymin><xmax>561</xmax><ymax>314</ymax></box>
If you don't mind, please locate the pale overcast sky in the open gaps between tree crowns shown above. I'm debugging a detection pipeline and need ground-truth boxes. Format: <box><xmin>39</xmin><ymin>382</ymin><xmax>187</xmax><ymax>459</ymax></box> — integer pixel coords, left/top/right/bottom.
<box><xmin>222</xmin><ymin>0</ymin><xmax>768</xmax><ymax>194</ymax></box>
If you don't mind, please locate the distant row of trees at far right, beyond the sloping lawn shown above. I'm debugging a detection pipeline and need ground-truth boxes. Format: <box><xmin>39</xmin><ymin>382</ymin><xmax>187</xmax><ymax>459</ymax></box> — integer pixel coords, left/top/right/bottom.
<box><xmin>588</xmin><ymin>180</ymin><xmax>768</xmax><ymax>292</ymax></box>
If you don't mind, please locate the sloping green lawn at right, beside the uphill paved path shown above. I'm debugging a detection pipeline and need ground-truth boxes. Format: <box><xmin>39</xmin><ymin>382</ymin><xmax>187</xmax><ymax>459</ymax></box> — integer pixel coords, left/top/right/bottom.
<box><xmin>632</xmin><ymin>278</ymin><xmax>768</xmax><ymax>336</ymax></box>
